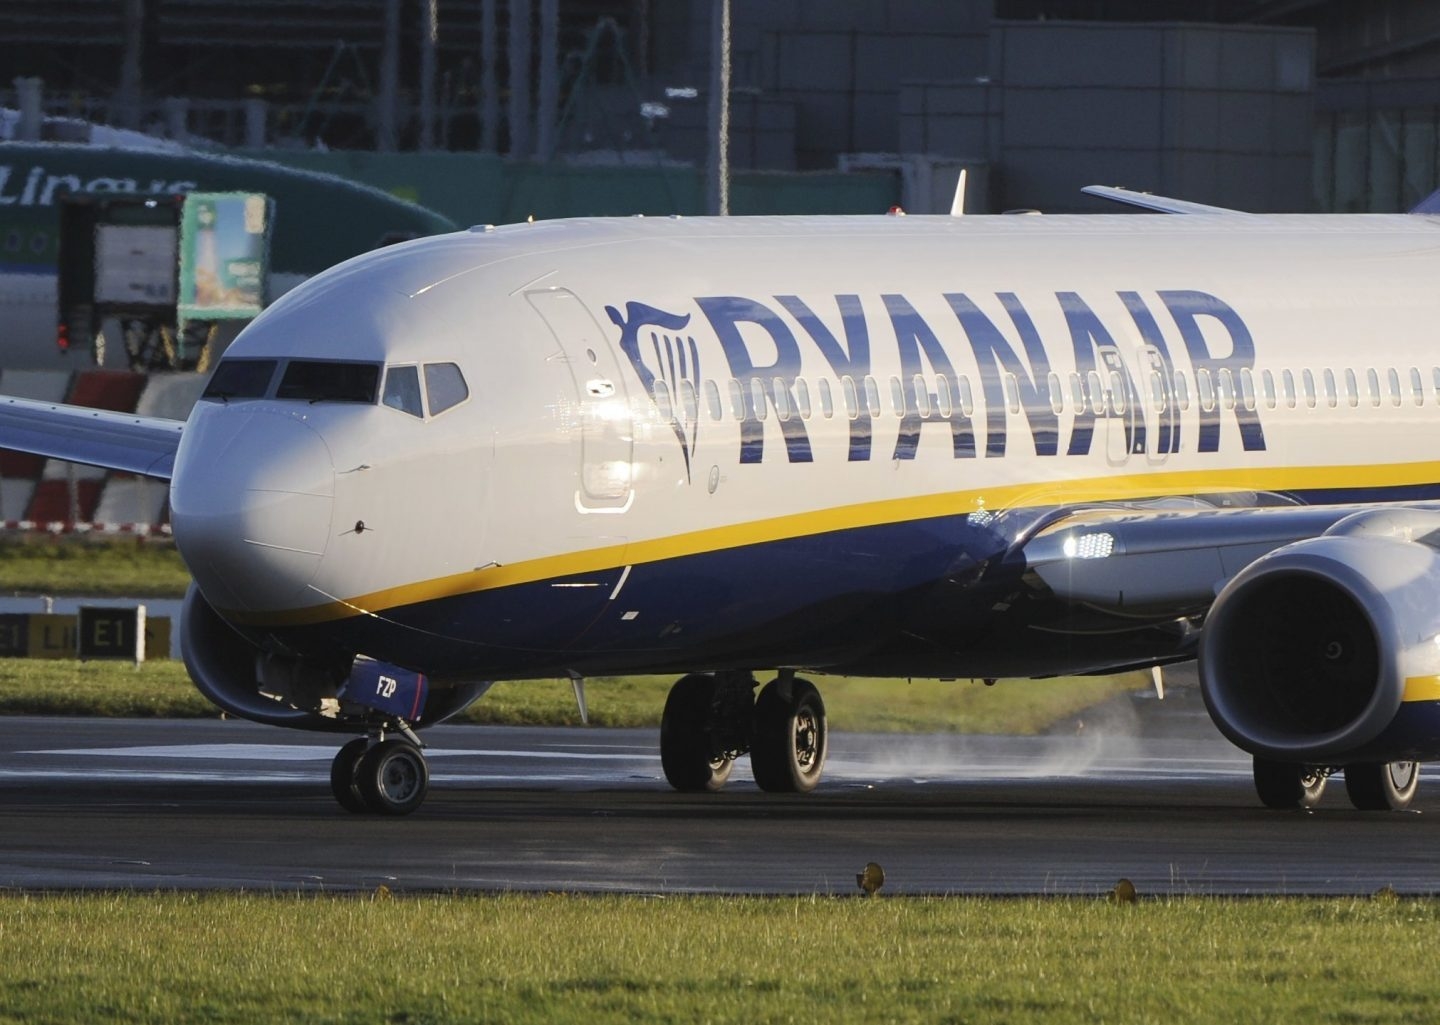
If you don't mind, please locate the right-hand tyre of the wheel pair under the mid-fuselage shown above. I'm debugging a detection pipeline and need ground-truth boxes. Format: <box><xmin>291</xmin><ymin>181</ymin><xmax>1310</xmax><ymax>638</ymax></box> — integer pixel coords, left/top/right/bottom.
<box><xmin>750</xmin><ymin>678</ymin><xmax>827</xmax><ymax>793</ymax></box>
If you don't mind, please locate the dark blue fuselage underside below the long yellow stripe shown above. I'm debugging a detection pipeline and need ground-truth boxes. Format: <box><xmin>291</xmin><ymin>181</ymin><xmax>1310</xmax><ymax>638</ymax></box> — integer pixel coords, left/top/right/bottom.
<box><xmin>265</xmin><ymin>485</ymin><xmax>1440</xmax><ymax>679</ymax></box>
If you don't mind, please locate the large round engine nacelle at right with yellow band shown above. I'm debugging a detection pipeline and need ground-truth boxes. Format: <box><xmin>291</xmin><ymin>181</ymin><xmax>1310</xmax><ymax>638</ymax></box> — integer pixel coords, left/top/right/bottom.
<box><xmin>1200</xmin><ymin>510</ymin><xmax>1440</xmax><ymax>766</ymax></box>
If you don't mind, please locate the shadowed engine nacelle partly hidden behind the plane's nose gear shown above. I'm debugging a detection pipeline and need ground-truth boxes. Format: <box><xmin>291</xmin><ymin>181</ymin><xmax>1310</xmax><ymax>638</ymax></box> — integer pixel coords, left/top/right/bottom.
<box><xmin>180</xmin><ymin>584</ymin><xmax>490</xmax><ymax>733</ymax></box>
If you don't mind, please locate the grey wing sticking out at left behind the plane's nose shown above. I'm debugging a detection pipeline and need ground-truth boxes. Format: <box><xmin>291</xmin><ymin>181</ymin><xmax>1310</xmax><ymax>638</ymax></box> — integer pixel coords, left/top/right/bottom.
<box><xmin>0</xmin><ymin>396</ymin><xmax>184</xmax><ymax>481</ymax></box>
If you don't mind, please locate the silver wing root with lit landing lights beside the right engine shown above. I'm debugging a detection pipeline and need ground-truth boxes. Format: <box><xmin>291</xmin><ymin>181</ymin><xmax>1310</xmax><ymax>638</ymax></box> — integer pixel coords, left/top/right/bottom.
<box><xmin>1020</xmin><ymin>505</ymin><xmax>1388</xmax><ymax>615</ymax></box>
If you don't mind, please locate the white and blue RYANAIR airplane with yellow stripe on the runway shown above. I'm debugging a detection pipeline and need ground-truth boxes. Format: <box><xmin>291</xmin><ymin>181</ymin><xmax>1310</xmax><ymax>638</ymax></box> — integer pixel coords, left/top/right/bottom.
<box><xmin>0</xmin><ymin>190</ymin><xmax>1440</xmax><ymax>815</ymax></box>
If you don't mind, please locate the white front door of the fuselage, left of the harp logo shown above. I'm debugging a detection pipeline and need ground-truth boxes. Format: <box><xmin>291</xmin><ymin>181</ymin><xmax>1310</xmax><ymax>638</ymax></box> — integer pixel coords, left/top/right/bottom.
<box><xmin>526</xmin><ymin>288</ymin><xmax>635</xmax><ymax>513</ymax></box>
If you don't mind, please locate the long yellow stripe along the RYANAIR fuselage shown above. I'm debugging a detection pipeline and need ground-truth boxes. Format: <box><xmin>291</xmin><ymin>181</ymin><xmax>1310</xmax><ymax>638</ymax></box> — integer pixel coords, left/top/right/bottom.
<box><xmin>225</xmin><ymin>456</ymin><xmax>1440</xmax><ymax>626</ymax></box>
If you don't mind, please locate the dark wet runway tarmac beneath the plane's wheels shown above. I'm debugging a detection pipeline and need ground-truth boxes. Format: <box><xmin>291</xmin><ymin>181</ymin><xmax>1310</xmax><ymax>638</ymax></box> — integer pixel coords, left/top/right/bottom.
<box><xmin>0</xmin><ymin>688</ymin><xmax>1440</xmax><ymax>894</ymax></box>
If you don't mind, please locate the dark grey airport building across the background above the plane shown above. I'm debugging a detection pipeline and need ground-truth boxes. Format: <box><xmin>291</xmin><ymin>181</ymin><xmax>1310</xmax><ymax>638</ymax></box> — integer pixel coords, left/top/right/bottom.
<box><xmin>0</xmin><ymin>0</ymin><xmax>1440</xmax><ymax>216</ymax></box>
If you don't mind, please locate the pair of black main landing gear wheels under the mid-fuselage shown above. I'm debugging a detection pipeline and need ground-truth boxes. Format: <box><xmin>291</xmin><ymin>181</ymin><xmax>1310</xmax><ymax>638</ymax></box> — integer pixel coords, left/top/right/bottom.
<box><xmin>660</xmin><ymin>671</ymin><xmax>825</xmax><ymax>793</ymax></box>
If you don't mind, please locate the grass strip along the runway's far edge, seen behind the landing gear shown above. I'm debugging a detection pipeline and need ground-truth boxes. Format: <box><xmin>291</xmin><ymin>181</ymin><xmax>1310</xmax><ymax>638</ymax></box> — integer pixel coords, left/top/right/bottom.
<box><xmin>0</xmin><ymin>658</ymin><xmax>1146</xmax><ymax>734</ymax></box>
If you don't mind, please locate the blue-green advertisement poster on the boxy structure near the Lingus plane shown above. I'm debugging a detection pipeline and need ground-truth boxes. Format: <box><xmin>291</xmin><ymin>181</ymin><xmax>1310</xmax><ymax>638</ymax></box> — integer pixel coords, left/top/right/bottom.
<box><xmin>177</xmin><ymin>193</ymin><xmax>274</xmax><ymax>322</ymax></box>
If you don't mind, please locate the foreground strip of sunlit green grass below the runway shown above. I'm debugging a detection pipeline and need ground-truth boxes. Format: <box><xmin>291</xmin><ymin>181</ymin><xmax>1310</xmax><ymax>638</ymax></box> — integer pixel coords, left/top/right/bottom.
<box><xmin>0</xmin><ymin>894</ymin><xmax>1440</xmax><ymax>1025</ymax></box>
